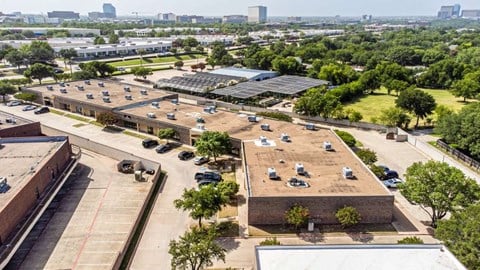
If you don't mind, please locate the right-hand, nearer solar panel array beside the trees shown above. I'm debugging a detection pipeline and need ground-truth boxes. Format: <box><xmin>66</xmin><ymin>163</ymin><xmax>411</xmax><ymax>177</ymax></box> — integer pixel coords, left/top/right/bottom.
<box><xmin>212</xmin><ymin>75</ymin><xmax>328</xmax><ymax>99</ymax></box>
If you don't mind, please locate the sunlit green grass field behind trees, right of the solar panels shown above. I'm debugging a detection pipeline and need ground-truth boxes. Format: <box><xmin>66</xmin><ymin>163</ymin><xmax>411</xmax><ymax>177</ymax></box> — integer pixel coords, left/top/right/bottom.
<box><xmin>345</xmin><ymin>89</ymin><xmax>472</xmax><ymax>121</ymax></box>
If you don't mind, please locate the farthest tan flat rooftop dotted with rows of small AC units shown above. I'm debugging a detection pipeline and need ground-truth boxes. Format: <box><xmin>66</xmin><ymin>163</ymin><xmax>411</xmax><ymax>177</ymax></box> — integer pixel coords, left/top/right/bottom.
<box><xmin>29</xmin><ymin>80</ymin><xmax>171</xmax><ymax>108</ymax></box>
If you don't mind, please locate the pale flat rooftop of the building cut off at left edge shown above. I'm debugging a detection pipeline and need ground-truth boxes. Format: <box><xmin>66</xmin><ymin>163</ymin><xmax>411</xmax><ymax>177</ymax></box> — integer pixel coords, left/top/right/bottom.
<box><xmin>0</xmin><ymin>137</ymin><xmax>65</xmax><ymax>209</ymax></box>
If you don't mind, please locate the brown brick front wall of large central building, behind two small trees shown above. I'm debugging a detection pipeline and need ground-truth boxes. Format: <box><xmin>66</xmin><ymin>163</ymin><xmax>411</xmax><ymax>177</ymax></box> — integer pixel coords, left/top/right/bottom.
<box><xmin>248</xmin><ymin>195</ymin><xmax>394</xmax><ymax>225</ymax></box>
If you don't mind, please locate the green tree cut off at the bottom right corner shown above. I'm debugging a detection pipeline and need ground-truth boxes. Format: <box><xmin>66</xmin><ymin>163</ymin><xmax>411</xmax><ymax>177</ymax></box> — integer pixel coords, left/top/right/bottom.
<box><xmin>435</xmin><ymin>203</ymin><xmax>480</xmax><ymax>270</ymax></box>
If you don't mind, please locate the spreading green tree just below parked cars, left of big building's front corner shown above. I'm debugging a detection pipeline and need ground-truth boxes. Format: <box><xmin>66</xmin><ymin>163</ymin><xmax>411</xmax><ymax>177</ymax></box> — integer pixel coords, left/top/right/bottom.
<box><xmin>173</xmin><ymin>185</ymin><xmax>229</xmax><ymax>227</ymax></box>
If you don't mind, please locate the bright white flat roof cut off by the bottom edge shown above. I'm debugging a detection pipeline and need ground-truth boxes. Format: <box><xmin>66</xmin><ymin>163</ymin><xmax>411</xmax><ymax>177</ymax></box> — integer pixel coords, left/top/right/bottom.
<box><xmin>255</xmin><ymin>245</ymin><xmax>466</xmax><ymax>270</ymax></box>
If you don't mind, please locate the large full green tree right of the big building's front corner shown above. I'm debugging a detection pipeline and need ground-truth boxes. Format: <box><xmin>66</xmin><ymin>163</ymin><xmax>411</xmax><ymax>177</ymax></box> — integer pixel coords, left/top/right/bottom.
<box><xmin>399</xmin><ymin>161</ymin><xmax>480</xmax><ymax>227</ymax></box>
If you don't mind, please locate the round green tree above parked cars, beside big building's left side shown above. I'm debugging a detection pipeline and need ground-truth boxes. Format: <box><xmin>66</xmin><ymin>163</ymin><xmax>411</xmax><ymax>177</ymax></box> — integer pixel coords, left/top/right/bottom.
<box><xmin>195</xmin><ymin>131</ymin><xmax>232</xmax><ymax>162</ymax></box>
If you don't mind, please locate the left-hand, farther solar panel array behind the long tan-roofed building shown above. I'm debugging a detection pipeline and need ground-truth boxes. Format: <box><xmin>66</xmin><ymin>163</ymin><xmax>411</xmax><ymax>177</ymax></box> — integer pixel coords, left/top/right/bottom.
<box><xmin>156</xmin><ymin>72</ymin><xmax>245</xmax><ymax>93</ymax></box>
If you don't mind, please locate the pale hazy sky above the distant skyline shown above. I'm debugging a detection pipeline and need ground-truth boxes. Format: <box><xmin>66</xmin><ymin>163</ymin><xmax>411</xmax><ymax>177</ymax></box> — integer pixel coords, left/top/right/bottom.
<box><xmin>0</xmin><ymin>0</ymin><xmax>480</xmax><ymax>16</ymax></box>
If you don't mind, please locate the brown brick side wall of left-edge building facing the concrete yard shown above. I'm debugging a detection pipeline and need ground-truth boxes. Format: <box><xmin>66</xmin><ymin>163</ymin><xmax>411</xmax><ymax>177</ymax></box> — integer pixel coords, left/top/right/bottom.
<box><xmin>0</xmin><ymin>141</ymin><xmax>72</xmax><ymax>242</ymax></box>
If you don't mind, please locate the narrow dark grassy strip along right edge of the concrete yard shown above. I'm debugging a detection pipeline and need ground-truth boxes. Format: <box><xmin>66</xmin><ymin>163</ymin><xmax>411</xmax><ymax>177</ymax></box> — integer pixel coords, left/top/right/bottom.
<box><xmin>119</xmin><ymin>171</ymin><xmax>167</xmax><ymax>269</ymax></box>
